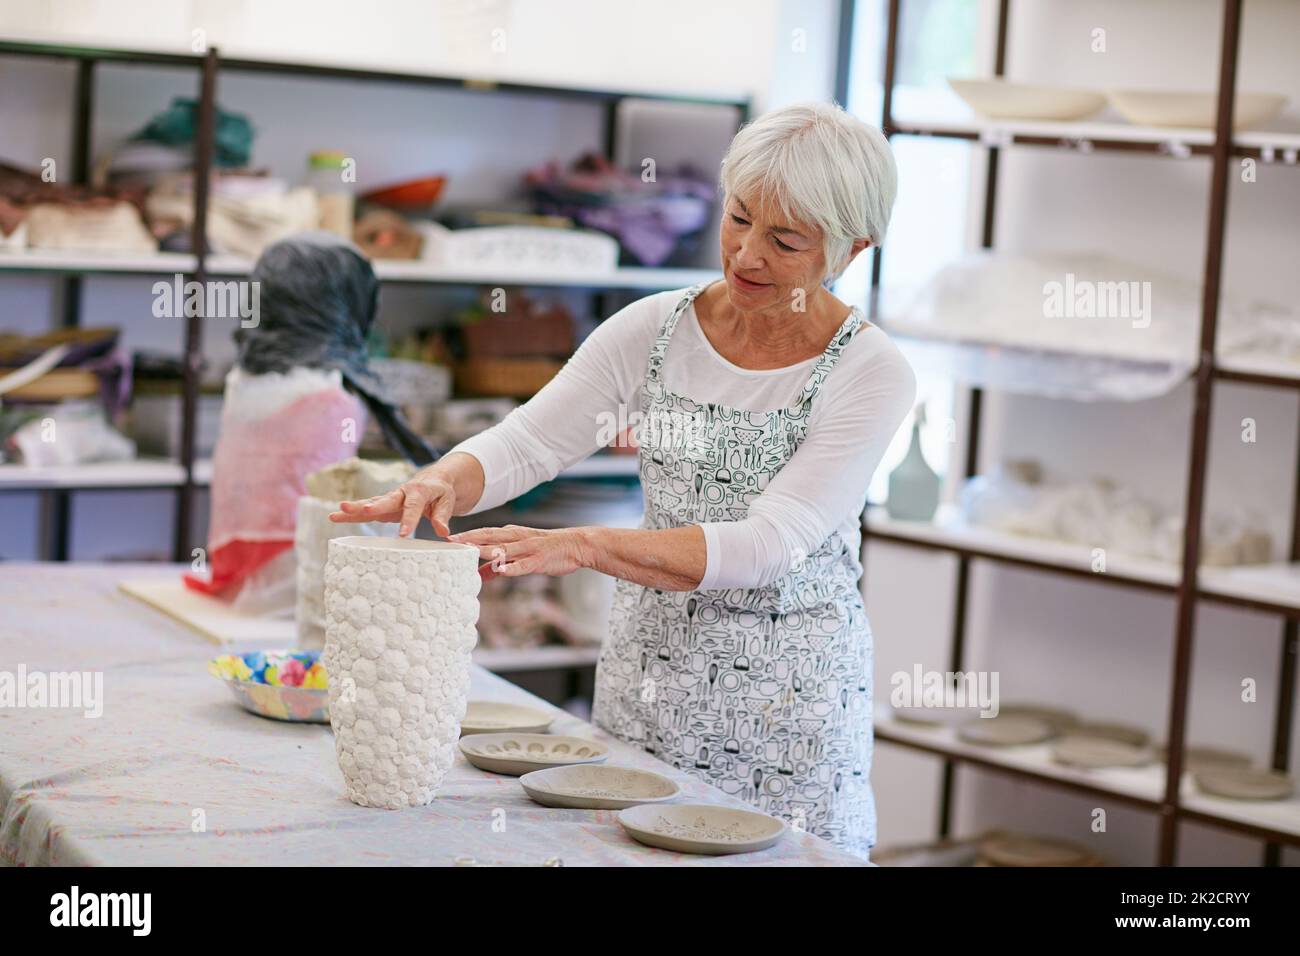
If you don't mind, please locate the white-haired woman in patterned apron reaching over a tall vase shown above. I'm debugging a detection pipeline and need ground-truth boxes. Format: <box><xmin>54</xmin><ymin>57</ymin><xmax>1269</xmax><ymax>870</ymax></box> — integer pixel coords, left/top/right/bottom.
<box><xmin>334</xmin><ymin>104</ymin><xmax>915</xmax><ymax>856</ymax></box>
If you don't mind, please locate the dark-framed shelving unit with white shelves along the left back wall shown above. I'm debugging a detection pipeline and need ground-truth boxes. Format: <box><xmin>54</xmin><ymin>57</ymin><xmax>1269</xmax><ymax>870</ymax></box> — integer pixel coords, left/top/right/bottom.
<box><xmin>0</xmin><ymin>42</ymin><xmax>750</xmax><ymax>561</ymax></box>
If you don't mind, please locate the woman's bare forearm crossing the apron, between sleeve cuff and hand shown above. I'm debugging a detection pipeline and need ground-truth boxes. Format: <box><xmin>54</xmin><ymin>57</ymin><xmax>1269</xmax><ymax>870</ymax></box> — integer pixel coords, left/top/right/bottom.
<box><xmin>581</xmin><ymin>524</ymin><xmax>707</xmax><ymax>591</ymax></box>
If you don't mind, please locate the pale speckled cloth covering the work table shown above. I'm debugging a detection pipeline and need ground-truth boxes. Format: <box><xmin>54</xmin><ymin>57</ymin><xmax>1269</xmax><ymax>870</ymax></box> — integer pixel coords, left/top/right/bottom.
<box><xmin>0</xmin><ymin>563</ymin><xmax>861</xmax><ymax>866</ymax></box>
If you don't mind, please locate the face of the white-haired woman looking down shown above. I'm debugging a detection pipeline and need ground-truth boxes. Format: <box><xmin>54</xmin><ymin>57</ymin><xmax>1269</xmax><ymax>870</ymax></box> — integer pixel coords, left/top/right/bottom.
<box><xmin>719</xmin><ymin>194</ymin><xmax>826</xmax><ymax>312</ymax></box>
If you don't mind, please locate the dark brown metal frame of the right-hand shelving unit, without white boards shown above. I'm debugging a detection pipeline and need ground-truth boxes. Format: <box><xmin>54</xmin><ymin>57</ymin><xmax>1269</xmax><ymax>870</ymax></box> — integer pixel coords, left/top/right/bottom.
<box><xmin>852</xmin><ymin>0</ymin><xmax>1300</xmax><ymax>866</ymax></box>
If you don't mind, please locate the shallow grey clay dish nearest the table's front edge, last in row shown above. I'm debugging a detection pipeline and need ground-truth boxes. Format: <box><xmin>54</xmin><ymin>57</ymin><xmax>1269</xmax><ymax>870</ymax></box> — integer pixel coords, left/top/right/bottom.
<box><xmin>619</xmin><ymin>804</ymin><xmax>788</xmax><ymax>856</ymax></box>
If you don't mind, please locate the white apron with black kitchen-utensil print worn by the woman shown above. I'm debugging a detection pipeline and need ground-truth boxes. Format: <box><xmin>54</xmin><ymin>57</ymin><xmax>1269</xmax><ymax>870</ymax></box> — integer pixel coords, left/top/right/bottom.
<box><xmin>593</xmin><ymin>284</ymin><xmax>876</xmax><ymax>857</ymax></box>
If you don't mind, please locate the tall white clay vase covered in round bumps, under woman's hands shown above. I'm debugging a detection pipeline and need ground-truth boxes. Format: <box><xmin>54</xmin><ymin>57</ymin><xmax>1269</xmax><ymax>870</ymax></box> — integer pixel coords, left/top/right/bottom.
<box><xmin>322</xmin><ymin>537</ymin><xmax>480</xmax><ymax>809</ymax></box>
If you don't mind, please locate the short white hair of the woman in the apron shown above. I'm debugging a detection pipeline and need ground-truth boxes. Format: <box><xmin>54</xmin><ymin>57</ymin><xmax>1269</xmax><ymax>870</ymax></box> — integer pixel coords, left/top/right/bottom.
<box><xmin>719</xmin><ymin>103</ymin><xmax>898</xmax><ymax>281</ymax></box>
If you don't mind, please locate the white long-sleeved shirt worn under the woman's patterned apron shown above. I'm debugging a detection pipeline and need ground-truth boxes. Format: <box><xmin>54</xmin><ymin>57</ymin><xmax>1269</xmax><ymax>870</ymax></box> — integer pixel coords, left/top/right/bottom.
<box><xmin>452</xmin><ymin>289</ymin><xmax>917</xmax><ymax>591</ymax></box>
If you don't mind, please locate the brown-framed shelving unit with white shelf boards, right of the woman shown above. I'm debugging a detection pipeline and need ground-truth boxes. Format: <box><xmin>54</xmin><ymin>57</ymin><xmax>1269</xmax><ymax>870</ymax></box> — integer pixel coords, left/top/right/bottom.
<box><xmin>840</xmin><ymin>0</ymin><xmax>1300</xmax><ymax>865</ymax></box>
